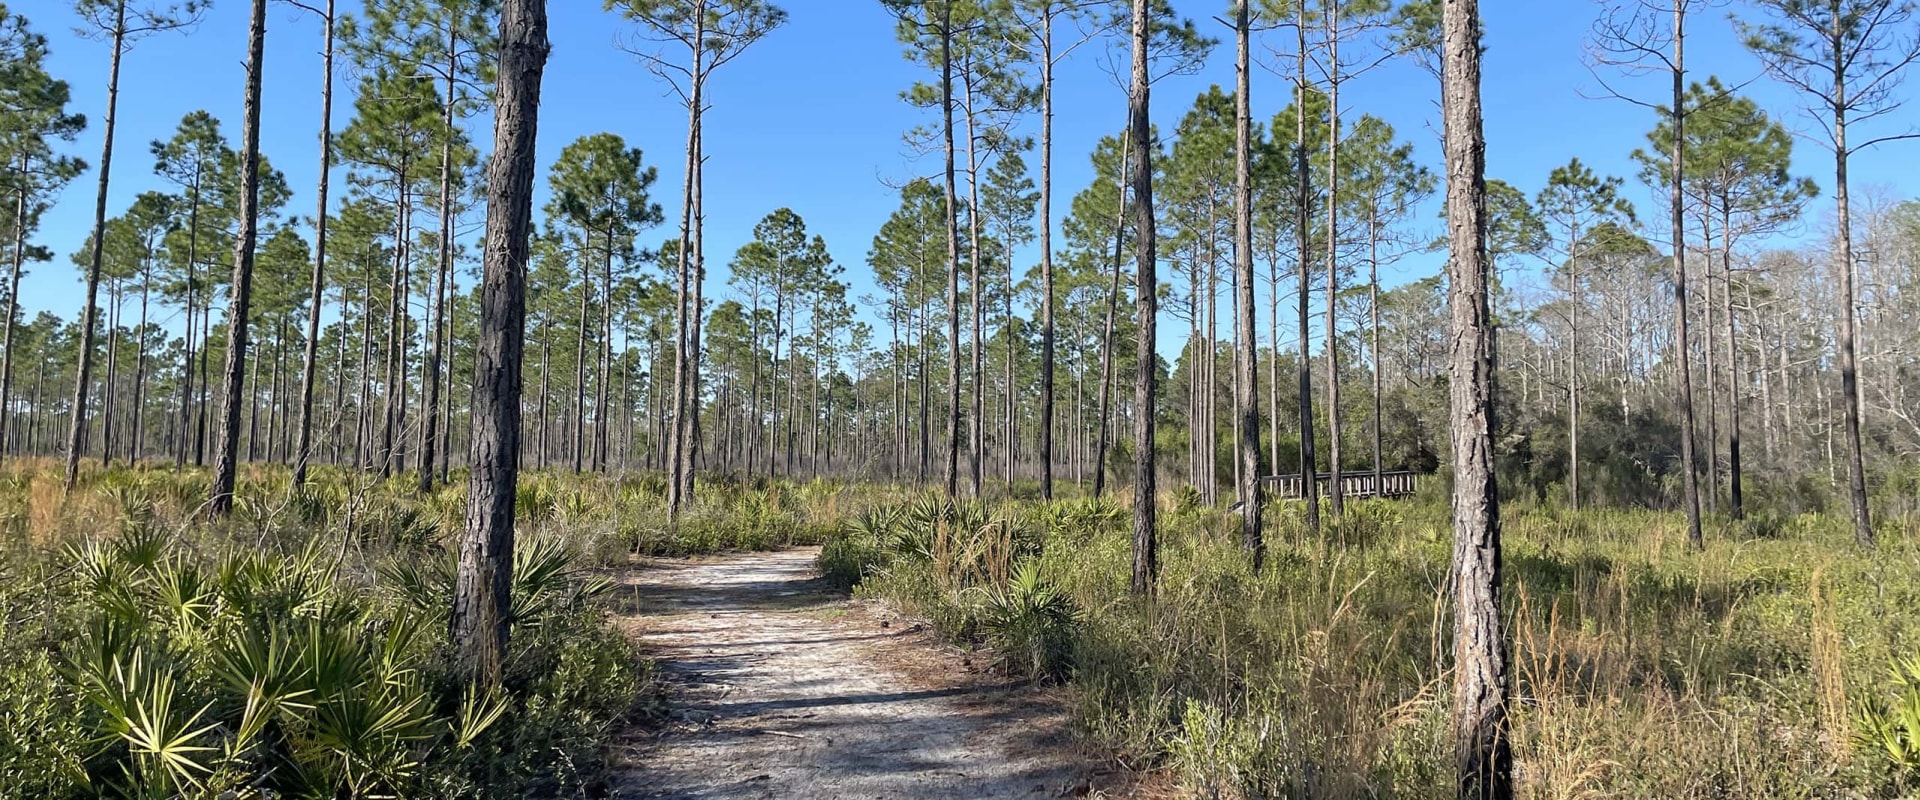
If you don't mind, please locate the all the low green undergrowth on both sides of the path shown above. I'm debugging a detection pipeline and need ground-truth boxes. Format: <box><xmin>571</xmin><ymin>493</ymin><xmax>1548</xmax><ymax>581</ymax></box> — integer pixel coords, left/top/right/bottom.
<box><xmin>0</xmin><ymin>452</ymin><xmax>1920</xmax><ymax>798</ymax></box>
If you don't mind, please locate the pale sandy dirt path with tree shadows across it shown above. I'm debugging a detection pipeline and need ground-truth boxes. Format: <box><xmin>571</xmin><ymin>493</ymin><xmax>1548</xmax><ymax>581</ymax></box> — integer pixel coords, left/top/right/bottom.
<box><xmin>616</xmin><ymin>549</ymin><xmax>1114</xmax><ymax>800</ymax></box>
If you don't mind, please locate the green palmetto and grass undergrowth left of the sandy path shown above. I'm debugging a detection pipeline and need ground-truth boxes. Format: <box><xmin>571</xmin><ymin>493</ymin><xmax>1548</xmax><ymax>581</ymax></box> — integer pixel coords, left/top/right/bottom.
<box><xmin>0</xmin><ymin>460</ymin><xmax>856</xmax><ymax>800</ymax></box>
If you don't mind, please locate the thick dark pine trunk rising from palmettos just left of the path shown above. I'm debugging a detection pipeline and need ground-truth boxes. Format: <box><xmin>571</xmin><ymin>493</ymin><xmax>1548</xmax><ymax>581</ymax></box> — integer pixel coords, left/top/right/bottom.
<box><xmin>449</xmin><ymin>0</ymin><xmax>549</xmax><ymax>685</ymax></box>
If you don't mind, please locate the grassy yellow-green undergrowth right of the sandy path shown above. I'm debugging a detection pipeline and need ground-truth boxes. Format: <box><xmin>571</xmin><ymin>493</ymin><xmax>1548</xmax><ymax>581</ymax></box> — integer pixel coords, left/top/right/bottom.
<box><xmin>822</xmin><ymin>477</ymin><xmax>1920</xmax><ymax>798</ymax></box>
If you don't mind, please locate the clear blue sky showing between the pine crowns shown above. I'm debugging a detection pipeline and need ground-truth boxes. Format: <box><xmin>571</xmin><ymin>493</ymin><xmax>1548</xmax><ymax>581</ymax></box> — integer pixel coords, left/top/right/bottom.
<box><xmin>12</xmin><ymin>0</ymin><xmax>1920</xmax><ymax>349</ymax></box>
